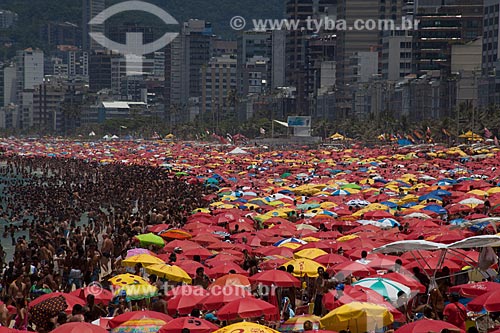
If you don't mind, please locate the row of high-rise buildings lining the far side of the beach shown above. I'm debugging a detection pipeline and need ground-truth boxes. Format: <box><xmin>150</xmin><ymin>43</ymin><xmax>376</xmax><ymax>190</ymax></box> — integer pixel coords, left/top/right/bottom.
<box><xmin>0</xmin><ymin>0</ymin><xmax>500</xmax><ymax>140</ymax></box>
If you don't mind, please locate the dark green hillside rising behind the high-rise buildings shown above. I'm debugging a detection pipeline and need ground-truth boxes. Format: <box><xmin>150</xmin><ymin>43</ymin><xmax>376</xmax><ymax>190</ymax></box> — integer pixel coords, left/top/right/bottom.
<box><xmin>0</xmin><ymin>0</ymin><xmax>283</xmax><ymax>58</ymax></box>
